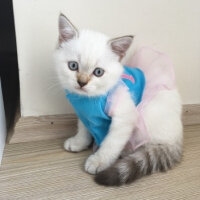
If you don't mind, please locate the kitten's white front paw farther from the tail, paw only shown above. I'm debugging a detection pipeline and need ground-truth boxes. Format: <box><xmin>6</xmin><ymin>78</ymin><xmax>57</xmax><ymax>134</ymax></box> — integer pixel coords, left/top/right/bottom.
<box><xmin>64</xmin><ymin>137</ymin><xmax>88</xmax><ymax>152</ymax></box>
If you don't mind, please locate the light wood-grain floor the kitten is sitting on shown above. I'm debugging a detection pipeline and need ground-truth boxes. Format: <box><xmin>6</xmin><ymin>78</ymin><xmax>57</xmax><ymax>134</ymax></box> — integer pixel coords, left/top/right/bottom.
<box><xmin>0</xmin><ymin>125</ymin><xmax>200</xmax><ymax>200</ymax></box>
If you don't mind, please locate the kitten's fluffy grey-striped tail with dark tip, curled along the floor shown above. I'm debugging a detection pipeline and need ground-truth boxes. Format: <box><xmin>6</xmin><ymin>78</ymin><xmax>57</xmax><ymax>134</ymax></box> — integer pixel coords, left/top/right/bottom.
<box><xmin>95</xmin><ymin>144</ymin><xmax>182</xmax><ymax>186</ymax></box>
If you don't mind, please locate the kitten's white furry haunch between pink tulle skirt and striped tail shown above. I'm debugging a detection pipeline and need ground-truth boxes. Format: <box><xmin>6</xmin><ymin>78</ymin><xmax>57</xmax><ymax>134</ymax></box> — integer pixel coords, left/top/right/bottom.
<box><xmin>143</xmin><ymin>89</ymin><xmax>183</xmax><ymax>145</ymax></box>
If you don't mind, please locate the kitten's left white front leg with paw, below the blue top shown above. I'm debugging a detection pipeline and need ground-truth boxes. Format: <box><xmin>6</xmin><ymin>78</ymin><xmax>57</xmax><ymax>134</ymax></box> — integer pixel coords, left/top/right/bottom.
<box><xmin>64</xmin><ymin>120</ymin><xmax>92</xmax><ymax>152</ymax></box>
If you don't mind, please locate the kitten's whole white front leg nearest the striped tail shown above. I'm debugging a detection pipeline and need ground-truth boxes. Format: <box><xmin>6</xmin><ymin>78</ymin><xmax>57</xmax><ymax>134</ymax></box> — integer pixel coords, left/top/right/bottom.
<box><xmin>85</xmin><ymin>91</ymin><xmax>138</xmax><ymax>174</ymax></box>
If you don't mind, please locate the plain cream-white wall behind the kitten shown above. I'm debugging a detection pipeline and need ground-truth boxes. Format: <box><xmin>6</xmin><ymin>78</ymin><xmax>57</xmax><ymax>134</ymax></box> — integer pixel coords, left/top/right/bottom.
<box><xmin>13</xmin><ymin>0</ymin><xmax>200</xmax><ymax>116</ymax></box>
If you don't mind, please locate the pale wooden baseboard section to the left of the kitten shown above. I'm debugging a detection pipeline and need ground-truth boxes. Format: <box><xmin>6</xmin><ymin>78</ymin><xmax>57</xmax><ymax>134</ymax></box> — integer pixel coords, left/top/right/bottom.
<box><xmin>9</xmin><ymin>114</ymin><xmax>77</xmax><ymax>143</ymax></box>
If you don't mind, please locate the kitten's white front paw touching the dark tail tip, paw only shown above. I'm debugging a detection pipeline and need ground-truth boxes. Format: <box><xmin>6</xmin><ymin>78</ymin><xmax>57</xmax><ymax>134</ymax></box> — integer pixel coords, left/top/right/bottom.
<box><xmin>85</xmin><ymin>153</ymin><xmax>111</xmax><ymax>174</ymax></box>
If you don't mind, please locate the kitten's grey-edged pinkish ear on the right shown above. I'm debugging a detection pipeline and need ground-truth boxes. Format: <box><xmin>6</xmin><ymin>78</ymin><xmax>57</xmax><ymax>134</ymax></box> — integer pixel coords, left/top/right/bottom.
<box><xmin>108</xmin><ymin>35</ymin><xmax>133</xmax><ymax>60</ymax></box>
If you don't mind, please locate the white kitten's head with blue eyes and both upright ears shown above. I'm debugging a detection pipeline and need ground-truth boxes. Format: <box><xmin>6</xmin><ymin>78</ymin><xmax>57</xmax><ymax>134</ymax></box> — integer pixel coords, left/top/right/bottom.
<box><xmin>54</xmin><ymin>14</ymin><xmax>133</xmax><ymax>96</ymax></box>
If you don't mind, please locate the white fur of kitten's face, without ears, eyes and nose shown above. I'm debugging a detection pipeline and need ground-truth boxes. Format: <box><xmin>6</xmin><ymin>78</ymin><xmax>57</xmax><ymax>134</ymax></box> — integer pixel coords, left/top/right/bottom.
<box><xmin>54</xmin><ymin>30</ymin><xmax>123</xmax><ymax>96</ymax></box>
